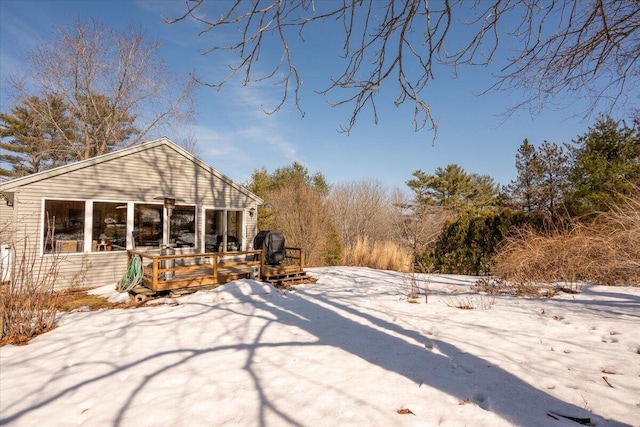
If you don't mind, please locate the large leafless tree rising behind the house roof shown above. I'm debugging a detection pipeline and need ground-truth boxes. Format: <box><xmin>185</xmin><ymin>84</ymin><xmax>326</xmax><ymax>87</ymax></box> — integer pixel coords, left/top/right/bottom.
<box><xmin>6</xmin><ymin>20</ymin><xmax>193</xmax><ymax>163</ymax></box>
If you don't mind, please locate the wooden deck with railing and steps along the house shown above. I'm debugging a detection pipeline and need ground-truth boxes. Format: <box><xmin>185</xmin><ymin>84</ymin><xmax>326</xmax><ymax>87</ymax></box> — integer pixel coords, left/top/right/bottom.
<box><xmin>128</xmin><ymin>248</ymin><xmax>311</xmax><ymax>293</ymax></box>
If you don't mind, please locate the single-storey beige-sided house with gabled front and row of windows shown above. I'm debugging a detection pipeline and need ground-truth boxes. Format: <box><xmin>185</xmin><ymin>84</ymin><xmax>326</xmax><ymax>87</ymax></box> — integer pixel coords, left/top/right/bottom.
<box><xmin>0</xmin><ymin>138</ymin><xmax>263</xmax><ymax>288</ymax></box>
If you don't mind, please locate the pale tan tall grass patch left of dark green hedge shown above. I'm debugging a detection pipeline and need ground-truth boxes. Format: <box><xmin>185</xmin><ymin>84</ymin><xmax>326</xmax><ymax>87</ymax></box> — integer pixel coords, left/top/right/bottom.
<box><xmin>342</xmin><ymin>237</ymin><xmax>413</xmax><ymax>272</ymax></box>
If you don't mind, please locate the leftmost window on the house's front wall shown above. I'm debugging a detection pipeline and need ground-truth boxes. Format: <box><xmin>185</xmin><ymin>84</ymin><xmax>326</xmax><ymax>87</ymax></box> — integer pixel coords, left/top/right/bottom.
<box><xmin>42</xmin><ymin>200</ymin><xmax>85</xmax><ymax>254</ymax></box>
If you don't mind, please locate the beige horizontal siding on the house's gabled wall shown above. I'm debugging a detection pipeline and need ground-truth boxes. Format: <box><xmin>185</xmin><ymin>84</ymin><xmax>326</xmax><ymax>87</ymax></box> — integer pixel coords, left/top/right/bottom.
<box><xmin>0</xmin><ymin>141</ymin><xmax>259</xmax><ymax>287</ymax></box>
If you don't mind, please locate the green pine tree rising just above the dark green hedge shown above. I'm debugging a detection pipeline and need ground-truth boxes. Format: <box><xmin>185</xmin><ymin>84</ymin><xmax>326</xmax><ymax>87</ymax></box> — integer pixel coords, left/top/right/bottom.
<box><xmin>407</xmin><ymin>164</ymin><xmax>498</xmax><ymax>213</ymax></box>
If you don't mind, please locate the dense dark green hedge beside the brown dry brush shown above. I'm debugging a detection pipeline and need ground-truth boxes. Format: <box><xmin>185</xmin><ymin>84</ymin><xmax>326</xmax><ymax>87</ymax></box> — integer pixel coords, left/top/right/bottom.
<box><xmin>421</xmin><ymin>209</ymin><xmax>543</xmax><ymax>275</ymax></box>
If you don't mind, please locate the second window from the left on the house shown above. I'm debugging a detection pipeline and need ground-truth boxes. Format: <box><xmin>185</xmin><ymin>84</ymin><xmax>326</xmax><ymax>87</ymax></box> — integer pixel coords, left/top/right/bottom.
<box><xmin>91</xmin><ymin>202</ymin><xmax>127</xmax><ymax>252</ymax></box>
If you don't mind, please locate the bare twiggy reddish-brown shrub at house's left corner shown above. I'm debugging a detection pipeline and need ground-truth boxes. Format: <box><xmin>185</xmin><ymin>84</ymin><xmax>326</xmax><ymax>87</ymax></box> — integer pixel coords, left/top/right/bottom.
<box><xmin>0</xmin><ymin>222</ymin><xmax>59</xmax><ymax>344</ymax></box>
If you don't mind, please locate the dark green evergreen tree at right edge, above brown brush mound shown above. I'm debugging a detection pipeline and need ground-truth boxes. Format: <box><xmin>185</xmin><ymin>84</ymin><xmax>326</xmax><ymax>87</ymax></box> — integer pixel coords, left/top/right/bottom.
<box><xmin>569</xmin><ymin>116</ymin><xmax>640</xmax><ymax>214</ymax></box>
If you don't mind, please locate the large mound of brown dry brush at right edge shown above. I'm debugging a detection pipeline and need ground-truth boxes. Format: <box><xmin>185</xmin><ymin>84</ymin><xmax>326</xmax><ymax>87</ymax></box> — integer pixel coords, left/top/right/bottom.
<box><xmin>493</xmin><ymin>196</ymin><xmax>640</xmax><ymax>286</ymax></box>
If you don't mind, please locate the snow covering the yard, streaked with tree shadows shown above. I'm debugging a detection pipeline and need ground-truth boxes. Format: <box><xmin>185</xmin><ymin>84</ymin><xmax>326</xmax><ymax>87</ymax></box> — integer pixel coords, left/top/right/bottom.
<box><xmin>0</xmin><ymin>267</ymin><xmax>640</xmax><ymax>426</ymax></box>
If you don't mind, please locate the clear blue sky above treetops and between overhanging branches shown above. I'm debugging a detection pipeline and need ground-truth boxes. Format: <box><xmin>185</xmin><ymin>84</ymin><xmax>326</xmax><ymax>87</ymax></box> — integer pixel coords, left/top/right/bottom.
<box><xmin>0</xmin><ymin>0</ymin><xmax>622</xmax><ymax>189</ymax></box>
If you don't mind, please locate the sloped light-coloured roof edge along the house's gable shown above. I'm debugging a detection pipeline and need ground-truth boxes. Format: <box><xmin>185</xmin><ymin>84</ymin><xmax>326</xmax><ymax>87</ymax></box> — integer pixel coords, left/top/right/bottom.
<box><xmin>0</xmin><ymin>137</ymin><xmax>264</xmax><ymax>204</ymax></box>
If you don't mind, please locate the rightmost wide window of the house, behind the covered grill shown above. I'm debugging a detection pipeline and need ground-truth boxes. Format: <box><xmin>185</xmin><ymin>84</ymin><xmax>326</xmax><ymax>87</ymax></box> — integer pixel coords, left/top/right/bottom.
<box><xmin>204</xmin><ymin>209</ymin><xmax>243</xmax><ymax>252</ymax></box>
